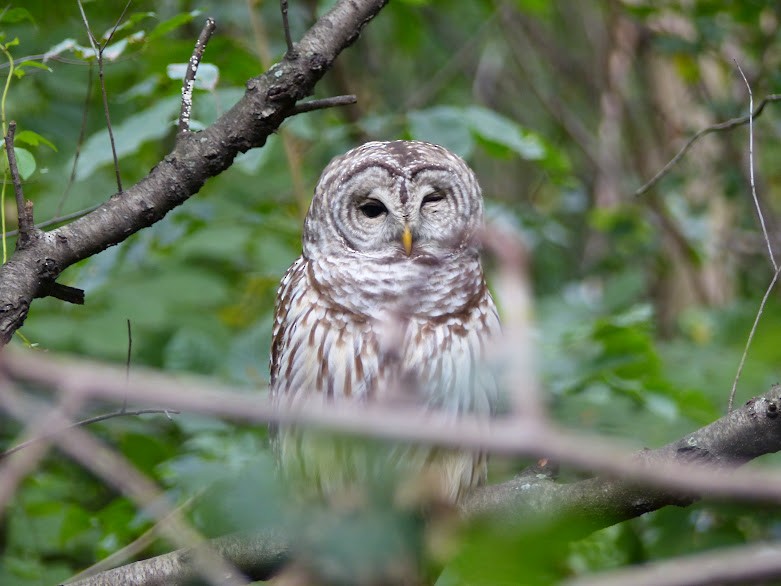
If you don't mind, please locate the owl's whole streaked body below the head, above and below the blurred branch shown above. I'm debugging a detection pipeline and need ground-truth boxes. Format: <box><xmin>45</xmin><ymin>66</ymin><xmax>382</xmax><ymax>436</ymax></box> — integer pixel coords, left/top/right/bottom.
<box><xmin>271</xmin><ymin>249</ymin><xmax>500</xmax><ymax>502</ymax></box>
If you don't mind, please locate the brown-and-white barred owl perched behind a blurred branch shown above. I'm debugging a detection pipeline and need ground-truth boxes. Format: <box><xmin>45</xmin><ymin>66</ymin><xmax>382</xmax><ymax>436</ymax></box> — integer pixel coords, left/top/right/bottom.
<box><xmin>271</xmin><ymin>141</ymin><xmax>500</xmax><ymax>502</ymax></box>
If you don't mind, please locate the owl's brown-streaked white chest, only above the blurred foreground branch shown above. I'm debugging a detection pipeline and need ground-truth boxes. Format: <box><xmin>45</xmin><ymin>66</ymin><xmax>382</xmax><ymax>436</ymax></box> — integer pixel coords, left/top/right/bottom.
<box><xmin>271</xmin><ymin>252</ymin><xmax>499</xmax><ymax>413</ymax></box>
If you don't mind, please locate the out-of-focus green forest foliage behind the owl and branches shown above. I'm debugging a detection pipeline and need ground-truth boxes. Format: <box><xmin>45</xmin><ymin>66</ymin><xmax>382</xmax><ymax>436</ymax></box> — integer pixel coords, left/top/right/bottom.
<box><xmin>0</xmin><ymin>0</ymin><xmax>781</xmax><ymax>586</ymax></box>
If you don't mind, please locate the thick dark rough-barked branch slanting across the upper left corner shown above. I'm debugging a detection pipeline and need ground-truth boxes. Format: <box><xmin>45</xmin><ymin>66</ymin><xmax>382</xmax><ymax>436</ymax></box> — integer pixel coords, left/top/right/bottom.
<box><xmin>0</xmin><ymin>0</ymin><xmax>387</xmax><ymax>345</ymax></box>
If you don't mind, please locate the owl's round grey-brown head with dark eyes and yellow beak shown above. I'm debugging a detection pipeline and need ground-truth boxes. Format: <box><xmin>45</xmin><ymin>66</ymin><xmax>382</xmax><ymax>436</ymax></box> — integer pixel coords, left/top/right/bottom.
<box><xmin>304</xmin><ymin>140</ymin><xmax>483</xmax><ymax>262</ymax></box>
